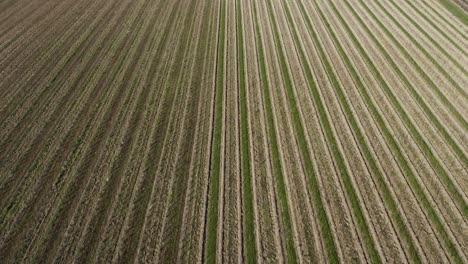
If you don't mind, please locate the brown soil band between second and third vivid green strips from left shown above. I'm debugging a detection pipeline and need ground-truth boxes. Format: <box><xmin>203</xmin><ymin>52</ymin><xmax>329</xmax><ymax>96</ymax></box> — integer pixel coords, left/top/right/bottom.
<box><xmin>250</xmin><ymin>0</ymin><xmax>289</xmax><ymax>256</ymax></box>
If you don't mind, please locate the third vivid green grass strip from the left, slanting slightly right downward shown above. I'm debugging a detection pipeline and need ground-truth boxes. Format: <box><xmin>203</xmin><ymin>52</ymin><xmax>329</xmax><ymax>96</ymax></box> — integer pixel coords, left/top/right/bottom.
<box><xmin>253</xmin><ymin>2</ymin><xmax>298</xmax><ymax>263</ymax></box>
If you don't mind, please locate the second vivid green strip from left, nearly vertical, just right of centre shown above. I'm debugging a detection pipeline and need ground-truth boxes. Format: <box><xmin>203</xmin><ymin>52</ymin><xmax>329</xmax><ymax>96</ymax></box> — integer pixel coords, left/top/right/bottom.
<box><xmin>236</xmin><ymin>0</ymin><xmax>257</xmax><ymax>263</ymax></box>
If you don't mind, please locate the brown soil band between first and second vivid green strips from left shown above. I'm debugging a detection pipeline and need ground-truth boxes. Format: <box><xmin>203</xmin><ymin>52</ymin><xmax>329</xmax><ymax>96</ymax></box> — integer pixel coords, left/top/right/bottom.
<box><xmin>219</xmin><ymin>1</ymin><xmax>242</xmax><ymax>263</ymax></box>
